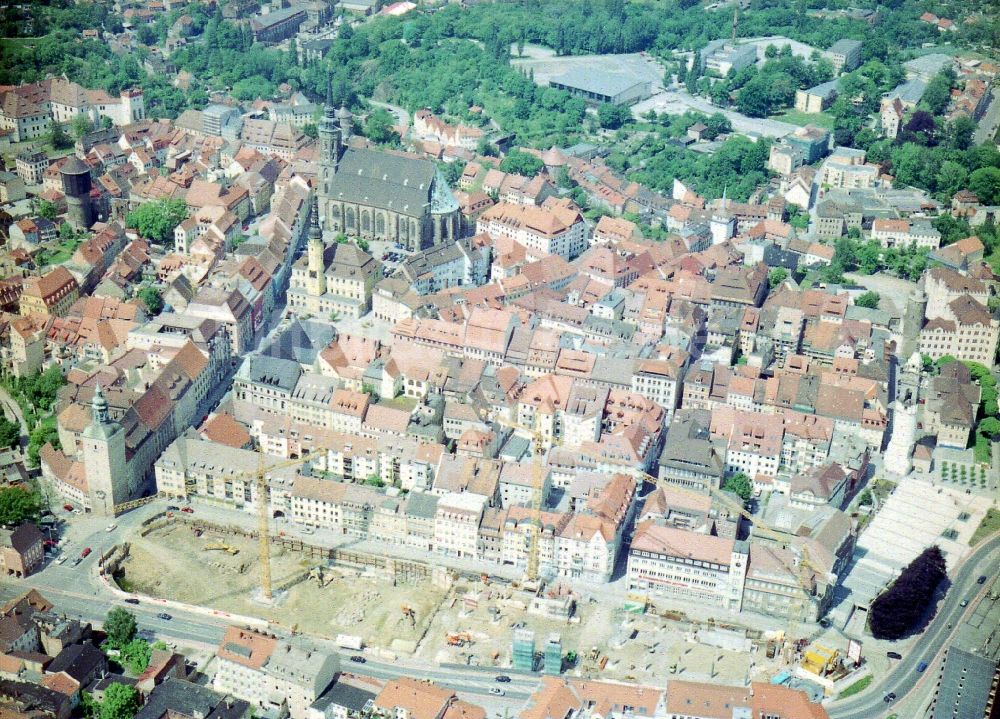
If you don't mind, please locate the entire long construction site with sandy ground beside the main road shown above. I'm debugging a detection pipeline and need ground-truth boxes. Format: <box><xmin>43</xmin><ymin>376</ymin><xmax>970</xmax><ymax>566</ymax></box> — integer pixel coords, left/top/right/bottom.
<box><xmin>115</xmin><ymin>518</ymin><xmax>777</xmax><ymax>682</ymax></box>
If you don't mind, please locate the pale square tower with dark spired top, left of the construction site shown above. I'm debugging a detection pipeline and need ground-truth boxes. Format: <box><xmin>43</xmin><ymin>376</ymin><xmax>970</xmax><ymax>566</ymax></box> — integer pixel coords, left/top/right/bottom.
<box><xmin>83</xmin><ymin>385</ymin><xmax>132</xmax><ymax>517</ymax></box>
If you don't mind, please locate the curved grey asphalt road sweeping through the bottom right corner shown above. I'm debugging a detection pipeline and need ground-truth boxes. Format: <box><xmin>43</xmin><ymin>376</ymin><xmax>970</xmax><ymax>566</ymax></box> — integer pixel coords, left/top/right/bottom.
<box><xmin>827</xmin><ymin>535</ymin><xmax>1000</xmax><ymax>719</ymax></box>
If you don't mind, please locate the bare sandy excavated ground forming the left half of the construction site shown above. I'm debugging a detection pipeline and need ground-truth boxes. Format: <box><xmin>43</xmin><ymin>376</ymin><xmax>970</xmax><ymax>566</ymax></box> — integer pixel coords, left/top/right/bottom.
<box><xmin>119</xmin><ymin>525</ymin><xmax>445</xmax><ymax>648</ymax></box>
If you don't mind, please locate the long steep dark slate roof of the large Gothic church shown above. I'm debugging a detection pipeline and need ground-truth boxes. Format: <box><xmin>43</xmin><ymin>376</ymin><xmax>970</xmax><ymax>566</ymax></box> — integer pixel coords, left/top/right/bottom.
<box><xmin>329</xmin><ymin>147</ymin><xmax>437</xmax><ymax>217</ymax></box>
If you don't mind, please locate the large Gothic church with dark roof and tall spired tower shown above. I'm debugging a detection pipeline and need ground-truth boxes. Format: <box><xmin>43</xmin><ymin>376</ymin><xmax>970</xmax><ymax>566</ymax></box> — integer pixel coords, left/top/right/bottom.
<box><xmin>316</xmin><ymin>80</ymin><xmax>462</xmax><ymax>251</ymax></box>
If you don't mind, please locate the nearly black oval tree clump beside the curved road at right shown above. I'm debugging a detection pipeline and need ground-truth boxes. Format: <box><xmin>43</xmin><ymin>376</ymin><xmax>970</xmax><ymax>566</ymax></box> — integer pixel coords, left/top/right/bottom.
<box><xmin>868</xmin><ymin>545</ymin><xmax>947</xmax><ymax>639</ymax></box>
